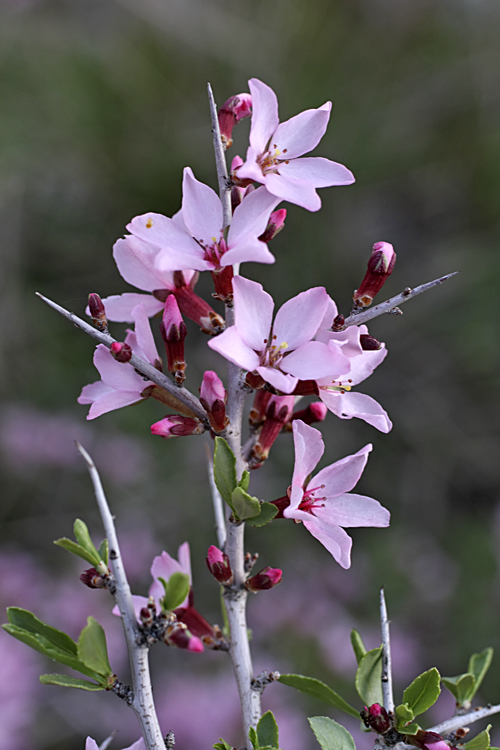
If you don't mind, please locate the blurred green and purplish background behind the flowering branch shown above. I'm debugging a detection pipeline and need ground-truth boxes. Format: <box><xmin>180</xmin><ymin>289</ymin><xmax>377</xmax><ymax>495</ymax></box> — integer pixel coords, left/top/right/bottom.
<box><xmin>0</xmin><ymin>0</ymin><xmax>500</xmax><ymax>750</ymax></box>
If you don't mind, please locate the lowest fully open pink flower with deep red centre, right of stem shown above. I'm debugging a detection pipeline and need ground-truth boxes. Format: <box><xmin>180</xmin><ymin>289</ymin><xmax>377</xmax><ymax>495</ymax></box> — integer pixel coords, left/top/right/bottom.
<box><xmin>283</xmin><ymin>419</ymin><xmax>390</xmax><ymax>568</ymax></box>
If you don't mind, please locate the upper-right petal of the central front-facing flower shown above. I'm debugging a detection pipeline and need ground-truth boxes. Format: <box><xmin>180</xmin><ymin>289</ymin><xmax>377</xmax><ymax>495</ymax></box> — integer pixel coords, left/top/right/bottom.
<box><xmin>273</xmin><ymin>286</ymin><xmax>328</xmax><ymax>349</ymax></box>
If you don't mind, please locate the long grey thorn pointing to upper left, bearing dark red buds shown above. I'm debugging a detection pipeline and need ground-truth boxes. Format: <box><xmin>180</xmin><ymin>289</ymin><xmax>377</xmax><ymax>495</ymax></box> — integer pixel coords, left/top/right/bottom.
<box><xmin>36</xmin><ymin>292</ymin><xmax>208</xmax><ymax>425</ymax></box>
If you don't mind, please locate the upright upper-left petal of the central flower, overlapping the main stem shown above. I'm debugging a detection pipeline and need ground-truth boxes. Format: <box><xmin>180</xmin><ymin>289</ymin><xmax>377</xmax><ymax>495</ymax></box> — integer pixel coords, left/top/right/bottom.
<box><xmin>233</xmin><ymin>276</ymin><xmax>274</xmax><ymax>354</ymax></box>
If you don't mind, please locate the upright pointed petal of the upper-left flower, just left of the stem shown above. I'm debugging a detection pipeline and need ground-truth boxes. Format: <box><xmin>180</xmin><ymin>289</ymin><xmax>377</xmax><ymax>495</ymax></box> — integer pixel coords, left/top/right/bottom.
<box><xmin>182</xmin><ymin>167</ymin><xmax>223</xmax><ymax>245</ymax></box>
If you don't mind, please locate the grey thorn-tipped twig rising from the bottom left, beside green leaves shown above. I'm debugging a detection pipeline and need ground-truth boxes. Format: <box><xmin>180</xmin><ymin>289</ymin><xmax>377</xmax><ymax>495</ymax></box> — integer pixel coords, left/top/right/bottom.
<box><xmin>76</xmin><ymin>443</ymin><xmax>165</xmax><ymax>750</ymax></box>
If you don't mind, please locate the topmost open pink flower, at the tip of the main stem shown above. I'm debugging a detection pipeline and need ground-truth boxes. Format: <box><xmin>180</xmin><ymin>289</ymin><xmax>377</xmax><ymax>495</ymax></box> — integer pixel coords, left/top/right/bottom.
<box><xmin>236</xmin><ymin>78</ymin><xmax>354</xmax><ymax>211</ymax></box>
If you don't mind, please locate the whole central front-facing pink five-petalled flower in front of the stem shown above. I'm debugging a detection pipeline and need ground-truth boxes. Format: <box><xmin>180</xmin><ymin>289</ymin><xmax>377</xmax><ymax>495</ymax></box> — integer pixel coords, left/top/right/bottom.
<box><xmin>208</xmin><ymin>276</ymin><xmax>349</xmax><ymax>393</ymax></box>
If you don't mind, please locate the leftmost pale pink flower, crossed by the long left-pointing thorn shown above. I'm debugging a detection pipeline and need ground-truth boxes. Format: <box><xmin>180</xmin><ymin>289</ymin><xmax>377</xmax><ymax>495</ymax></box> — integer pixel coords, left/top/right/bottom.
<box><xmin>78</xmin><ymin>305</ymin><xmax>160</xmax><ymax>419</ymax></box>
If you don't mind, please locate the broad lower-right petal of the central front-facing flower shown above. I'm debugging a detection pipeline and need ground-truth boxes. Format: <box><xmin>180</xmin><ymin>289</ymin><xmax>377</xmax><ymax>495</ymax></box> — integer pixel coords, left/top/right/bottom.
<box><xmin>281</xmin><ymin>341</ymin><xmax>350</xmax><ymax>380</ymax></box>
